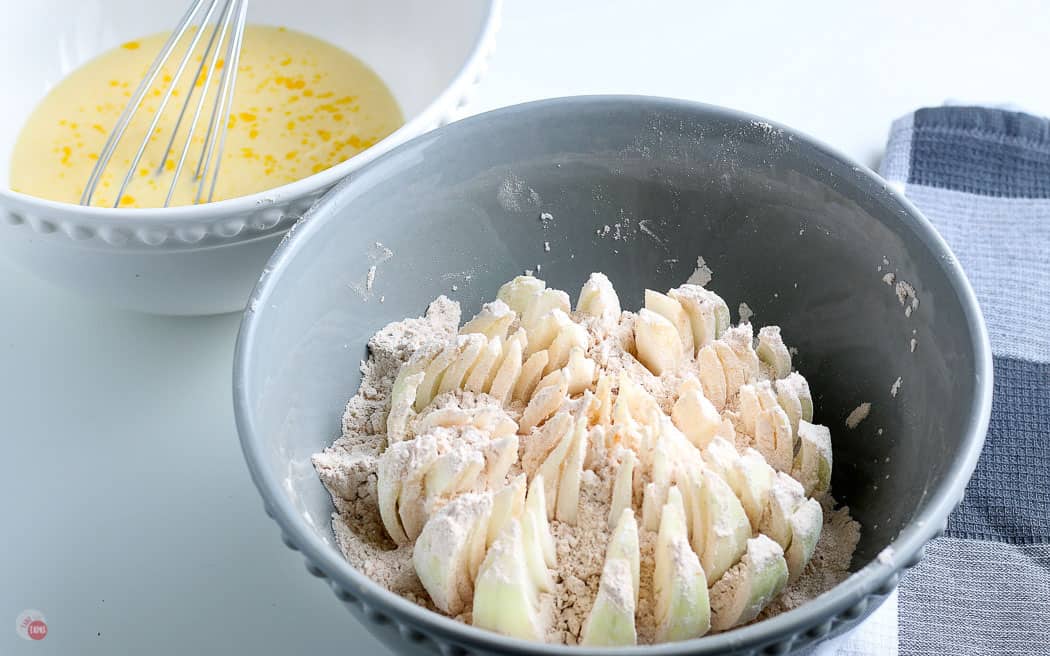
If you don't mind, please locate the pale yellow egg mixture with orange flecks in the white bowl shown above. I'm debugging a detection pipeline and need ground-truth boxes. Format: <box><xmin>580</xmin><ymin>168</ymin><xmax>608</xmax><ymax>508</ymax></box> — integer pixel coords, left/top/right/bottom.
<box><xmin>11</xmin><ymin>25</ymin><xmax>404</xmax><ymax>208</ymax></box>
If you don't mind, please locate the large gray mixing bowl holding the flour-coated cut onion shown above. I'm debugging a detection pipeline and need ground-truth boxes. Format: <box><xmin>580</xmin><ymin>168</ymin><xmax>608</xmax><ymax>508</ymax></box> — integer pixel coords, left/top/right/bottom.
<box><xmin>234</xmin><ymin>97</ymin><xmax>992</xmax><ymax>655</ymax></box>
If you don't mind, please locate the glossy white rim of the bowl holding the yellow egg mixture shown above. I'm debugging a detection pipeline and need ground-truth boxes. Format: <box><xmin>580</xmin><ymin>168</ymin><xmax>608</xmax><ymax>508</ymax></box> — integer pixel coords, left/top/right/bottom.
<box><xmin>0</xmin><ymin>0</ymin><xmax>503</xmax><ymax>227</ymax></box>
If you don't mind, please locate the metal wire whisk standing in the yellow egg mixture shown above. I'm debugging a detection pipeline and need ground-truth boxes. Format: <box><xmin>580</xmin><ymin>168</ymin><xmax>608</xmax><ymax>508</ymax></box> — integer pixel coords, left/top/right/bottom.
<box><xmin>80</xmin><ymin>0</ymin><xmax>248</xmax><ymax>207</ymax></box>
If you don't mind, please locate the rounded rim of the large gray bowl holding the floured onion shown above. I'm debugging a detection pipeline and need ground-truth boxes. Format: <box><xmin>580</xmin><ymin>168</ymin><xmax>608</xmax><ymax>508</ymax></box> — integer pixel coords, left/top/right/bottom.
<box><xmin>233</xmin><ymin>94</ymin><xmax>993</xmax><ymax>656</ymax></box>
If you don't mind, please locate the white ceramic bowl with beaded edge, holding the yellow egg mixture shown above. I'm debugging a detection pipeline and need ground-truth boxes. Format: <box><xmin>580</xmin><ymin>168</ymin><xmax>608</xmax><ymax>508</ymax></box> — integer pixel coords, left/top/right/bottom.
<box><xmin>0</xmin><ymin>0</ymin><xmax>501</xmax><ymax>315</ymax></box>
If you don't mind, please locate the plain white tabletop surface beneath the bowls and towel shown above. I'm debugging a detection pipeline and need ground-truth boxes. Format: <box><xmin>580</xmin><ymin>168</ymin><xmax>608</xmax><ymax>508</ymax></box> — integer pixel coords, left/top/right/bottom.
<box><xmin>0</xmin><ymin>0</ymin><xmax>1050</xmax><ymax>655</ymax></box>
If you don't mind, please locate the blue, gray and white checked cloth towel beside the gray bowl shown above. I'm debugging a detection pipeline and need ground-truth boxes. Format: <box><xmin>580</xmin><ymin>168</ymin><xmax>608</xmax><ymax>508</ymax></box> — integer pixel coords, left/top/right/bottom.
<box><xmin>818</xmin><ymin>107</ymin><xmax>1050</xmax><ymax>656</ymax></box>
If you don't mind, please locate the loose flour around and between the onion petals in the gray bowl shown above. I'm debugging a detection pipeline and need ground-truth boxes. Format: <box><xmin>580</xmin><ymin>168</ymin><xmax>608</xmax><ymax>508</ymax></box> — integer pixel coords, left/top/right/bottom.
<box><xmin>313</xmin><ymin>283</ymin><xmax>860</xmax><ymax>644</ymax></box>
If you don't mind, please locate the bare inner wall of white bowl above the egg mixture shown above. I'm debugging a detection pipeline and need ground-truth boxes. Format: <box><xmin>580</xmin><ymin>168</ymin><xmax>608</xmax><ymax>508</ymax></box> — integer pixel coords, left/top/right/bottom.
<box><xmin>0</xmin><ymin>0</ymin><xmax>489</xmax><ymax>188</ymax></box>
